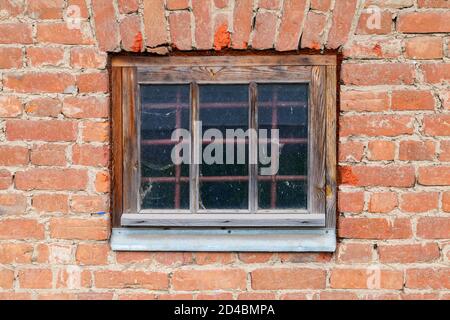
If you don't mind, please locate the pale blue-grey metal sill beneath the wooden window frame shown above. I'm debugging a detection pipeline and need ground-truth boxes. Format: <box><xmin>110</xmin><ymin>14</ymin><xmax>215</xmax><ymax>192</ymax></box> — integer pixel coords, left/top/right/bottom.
<box><xmin>111</xmin><ymin>228</ymin><xmax>336</xmax><ymax>252</ymax></box>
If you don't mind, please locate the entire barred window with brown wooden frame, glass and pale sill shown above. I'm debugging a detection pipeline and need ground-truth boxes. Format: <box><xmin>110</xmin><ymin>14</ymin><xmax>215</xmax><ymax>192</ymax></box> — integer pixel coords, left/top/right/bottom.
<box><xmin>112</xmin><ymin>55</ymin><xmax>336</xmax><ymax>251</ymax></box>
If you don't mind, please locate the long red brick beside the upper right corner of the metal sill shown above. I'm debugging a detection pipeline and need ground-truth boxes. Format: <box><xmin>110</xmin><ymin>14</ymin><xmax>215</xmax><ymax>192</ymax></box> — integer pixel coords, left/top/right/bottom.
<box><xmin>338</xmin><ymin>218</ymin><xmax>412</xmax><ymax>240</ymax></box>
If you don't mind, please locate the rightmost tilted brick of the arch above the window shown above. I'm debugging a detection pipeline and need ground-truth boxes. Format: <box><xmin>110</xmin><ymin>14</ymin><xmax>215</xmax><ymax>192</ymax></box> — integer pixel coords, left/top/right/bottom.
<box><xmin>327</xmin><ymin>0</ymin><xmax>358</xmax><ymax>49</ymax></box>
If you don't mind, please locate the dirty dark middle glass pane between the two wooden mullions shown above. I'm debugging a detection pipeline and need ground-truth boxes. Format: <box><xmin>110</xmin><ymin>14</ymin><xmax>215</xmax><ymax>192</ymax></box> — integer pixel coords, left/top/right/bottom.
<box><xmin>199</xmin><ymin>85</ymin><xmax>249</xmax><ymax>210</ymax></box>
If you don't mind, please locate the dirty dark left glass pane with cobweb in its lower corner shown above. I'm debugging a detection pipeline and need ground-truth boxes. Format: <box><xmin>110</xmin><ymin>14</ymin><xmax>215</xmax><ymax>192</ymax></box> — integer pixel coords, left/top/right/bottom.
<box><xmin>140</xmin><ymin>85</ymin><xmax>190</xmax><ymax>209</ymax></box>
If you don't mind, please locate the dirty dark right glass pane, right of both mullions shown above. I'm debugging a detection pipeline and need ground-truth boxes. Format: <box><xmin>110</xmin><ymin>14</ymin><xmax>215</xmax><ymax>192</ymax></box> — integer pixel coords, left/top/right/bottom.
<box><xmin>258</xmin><ymin>84</ymin><xmax>308</xmax><ymax>209</ymax></box>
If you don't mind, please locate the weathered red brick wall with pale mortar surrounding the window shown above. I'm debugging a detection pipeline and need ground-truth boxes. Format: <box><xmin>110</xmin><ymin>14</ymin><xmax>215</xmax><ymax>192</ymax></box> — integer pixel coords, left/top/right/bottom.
<box><xmin>0</xmin><ymin>0</ymin><xmax>450</xmax><ymax>299</ymax></box>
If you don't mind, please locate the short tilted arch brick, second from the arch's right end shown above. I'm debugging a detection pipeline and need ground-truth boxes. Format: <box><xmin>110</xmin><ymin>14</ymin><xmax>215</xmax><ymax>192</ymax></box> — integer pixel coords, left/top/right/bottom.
<box><xmin>301</xmin><ymin>11</ymin><xmax>327</xmax><ymax>50</ymax></box>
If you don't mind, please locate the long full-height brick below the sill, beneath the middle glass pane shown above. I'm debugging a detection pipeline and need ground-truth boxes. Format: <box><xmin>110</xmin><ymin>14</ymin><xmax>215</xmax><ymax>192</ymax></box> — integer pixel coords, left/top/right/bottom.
<box><xmin>172</xmin><ymin>269</ymin><xmax>247</xmax><ymax>291</ymax></box>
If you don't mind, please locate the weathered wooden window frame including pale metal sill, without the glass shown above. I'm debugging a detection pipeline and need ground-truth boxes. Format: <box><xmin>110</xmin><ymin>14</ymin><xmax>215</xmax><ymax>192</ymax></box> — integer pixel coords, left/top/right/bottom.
<box><xmin>111</xmin><ymin>55</ymin><xmax>337</xmax><ymax>251</ymax></box>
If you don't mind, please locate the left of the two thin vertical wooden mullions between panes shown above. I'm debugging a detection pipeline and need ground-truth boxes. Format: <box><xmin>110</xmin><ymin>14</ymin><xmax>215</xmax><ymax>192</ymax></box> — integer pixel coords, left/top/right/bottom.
<box><xmin>189</xmin><ymin>82</ymin><xmax>201</xmax><ymax>213</ymax></box>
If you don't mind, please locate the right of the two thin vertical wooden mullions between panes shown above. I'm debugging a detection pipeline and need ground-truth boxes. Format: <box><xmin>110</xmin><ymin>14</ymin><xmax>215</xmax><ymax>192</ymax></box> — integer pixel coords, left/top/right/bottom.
<box><xmin>248</xmin><ymin>82</ymin><xmax>258</xmax><ymax>213</ymax></box>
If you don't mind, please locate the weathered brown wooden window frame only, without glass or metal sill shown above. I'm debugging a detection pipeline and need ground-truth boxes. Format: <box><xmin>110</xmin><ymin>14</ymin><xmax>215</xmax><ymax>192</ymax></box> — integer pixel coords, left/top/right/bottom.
<box><xmin>111</xmin><ymin>55</ymin><xmax>337</xmax><ymax>248</ymax></box>
